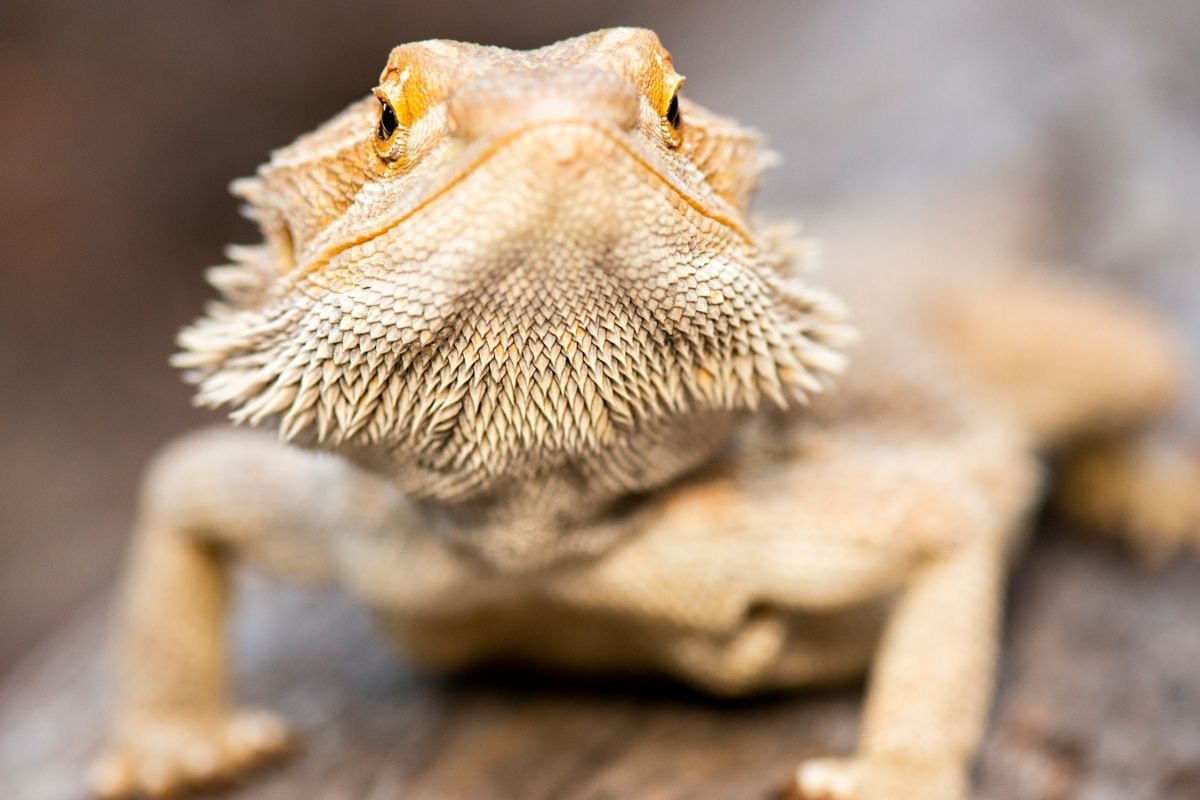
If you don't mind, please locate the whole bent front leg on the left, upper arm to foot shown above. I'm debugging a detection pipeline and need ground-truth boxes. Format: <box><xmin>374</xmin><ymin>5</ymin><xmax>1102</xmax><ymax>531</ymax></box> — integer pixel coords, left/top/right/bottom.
<box><xmin>91</xmin><ymin>431</ymin><xmax>384</xmax><ymax>798</ymax></box>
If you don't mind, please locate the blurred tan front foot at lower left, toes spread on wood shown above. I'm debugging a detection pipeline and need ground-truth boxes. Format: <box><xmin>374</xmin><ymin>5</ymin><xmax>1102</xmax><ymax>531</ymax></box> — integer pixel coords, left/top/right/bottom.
<box><xmin>90</xmin><ymin>710</ymin><xmax>293</xmax><ymax>800</ymax></box>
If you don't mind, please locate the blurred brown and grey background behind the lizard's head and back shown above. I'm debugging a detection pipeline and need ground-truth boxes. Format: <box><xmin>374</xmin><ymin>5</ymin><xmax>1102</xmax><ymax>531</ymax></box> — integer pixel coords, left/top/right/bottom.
<box><xmin>0</xmin><ymin>0</ymin><xmax>1200</xmax><ymax>674</ymax></box>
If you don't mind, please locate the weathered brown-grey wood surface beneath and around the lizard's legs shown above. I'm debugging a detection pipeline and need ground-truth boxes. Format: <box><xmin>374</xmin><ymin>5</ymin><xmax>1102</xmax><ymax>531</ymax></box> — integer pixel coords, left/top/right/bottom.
<box><xmin>0</xmin><ymin>533</ymin><xmax>1200</xmax><ymax>800</ymax></box>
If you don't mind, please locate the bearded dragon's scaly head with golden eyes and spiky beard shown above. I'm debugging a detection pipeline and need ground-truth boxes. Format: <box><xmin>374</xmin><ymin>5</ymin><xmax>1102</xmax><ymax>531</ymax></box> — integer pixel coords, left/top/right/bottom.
<box><xmin>176</xmin><ymin>29</ymin><xmax>842</xmax><ymax>499</ymax></box>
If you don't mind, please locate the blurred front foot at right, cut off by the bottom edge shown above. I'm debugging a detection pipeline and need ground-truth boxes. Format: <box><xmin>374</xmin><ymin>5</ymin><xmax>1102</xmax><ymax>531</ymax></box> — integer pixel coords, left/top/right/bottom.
<box><xmin>791</xmin><ymin>758</ymin><xmax>967</xmax><ymax>800</ymax></box>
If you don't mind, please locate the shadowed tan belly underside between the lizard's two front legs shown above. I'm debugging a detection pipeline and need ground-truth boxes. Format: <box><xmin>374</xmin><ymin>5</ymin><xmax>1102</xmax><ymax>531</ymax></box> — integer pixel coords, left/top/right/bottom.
<box><xmin>343</xmin><ymin>522</ymin><xmax>888</xmax><ymax>694</ymax></box>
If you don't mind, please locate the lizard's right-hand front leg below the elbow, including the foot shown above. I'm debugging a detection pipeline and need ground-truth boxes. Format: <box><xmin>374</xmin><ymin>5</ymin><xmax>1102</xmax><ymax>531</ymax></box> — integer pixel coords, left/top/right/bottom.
<box><xmin>797</xmin><ymin>527</ymin><xmax>1007</xmax><ymax>800</ymax></box>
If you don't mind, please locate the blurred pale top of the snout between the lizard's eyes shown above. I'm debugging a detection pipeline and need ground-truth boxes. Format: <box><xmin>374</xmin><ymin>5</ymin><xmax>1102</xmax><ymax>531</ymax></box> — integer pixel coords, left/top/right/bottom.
<box><xmin>449</xmin><ymin>70</ymin><xmax>640</xmax><ymax>143</ymax></box>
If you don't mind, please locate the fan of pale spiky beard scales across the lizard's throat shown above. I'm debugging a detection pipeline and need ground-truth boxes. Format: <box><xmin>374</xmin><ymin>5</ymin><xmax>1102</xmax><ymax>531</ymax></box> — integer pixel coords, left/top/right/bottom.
<box><xmin>175</xmin><ymin>221</ymin><xmax>845</xmax><ymax>500</ymax></box>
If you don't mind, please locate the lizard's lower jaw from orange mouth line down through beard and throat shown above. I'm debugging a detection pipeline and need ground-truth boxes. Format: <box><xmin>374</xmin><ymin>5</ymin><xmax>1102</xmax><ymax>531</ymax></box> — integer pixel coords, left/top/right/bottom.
<box><xmin>175</xmin><ymin>115</ymin><xmax>841</xmax><ymax>500</ymax></box>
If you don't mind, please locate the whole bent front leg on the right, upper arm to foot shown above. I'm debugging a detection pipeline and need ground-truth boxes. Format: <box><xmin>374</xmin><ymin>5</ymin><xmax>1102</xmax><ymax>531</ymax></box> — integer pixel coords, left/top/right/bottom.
<box><xmin>700</xmin><ymin>428</ymin><xmax>1038</xmax><ymax>800</ymax></box>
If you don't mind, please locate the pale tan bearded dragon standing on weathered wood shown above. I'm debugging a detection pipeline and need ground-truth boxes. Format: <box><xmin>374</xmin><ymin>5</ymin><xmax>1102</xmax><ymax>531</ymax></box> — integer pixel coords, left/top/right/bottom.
<box><xmin>91</xmin><ymin>29</ymin><xmax>1200</xmax><ymax>800</ymax></box>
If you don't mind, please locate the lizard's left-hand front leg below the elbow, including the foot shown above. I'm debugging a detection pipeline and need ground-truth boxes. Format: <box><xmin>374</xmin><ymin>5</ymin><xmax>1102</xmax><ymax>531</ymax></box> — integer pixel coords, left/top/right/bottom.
<box><xmin>92</xmin><ymin>501</ymin><xmax>289</xmax><ymax>798</ymax></box>
